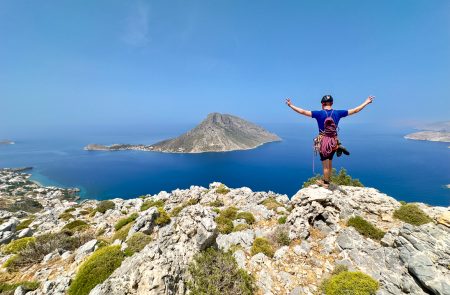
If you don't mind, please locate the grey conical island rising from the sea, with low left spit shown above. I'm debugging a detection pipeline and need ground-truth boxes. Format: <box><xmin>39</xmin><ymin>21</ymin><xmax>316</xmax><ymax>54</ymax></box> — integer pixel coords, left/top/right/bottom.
<box><xmin>84</xmin><ymin>113</ymin><xmax>281</xmax><ymax>153</ymax></box>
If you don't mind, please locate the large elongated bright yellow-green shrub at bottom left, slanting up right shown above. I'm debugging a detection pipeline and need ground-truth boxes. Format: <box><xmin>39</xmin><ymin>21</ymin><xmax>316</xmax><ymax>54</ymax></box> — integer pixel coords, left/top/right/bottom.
<box><xmin>68</xmin><ymin>246</ymin><xmax>125</xmax><ymax>295</ymax></box>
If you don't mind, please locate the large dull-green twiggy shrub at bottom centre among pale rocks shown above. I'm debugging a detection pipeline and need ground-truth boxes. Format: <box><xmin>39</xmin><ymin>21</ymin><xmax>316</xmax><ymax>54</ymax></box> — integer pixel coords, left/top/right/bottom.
<box><xmin>188</xmin><ymin>248</ymin><xmax>256</xmax><ymax>295</ymax></box>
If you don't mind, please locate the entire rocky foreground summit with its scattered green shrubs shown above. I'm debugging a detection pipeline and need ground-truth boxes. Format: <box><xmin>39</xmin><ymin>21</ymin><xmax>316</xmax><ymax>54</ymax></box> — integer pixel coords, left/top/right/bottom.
<box><xmin>0</xmin><ymin>171</ymin><xmax>450</xmax><ymax>295</ymax></box>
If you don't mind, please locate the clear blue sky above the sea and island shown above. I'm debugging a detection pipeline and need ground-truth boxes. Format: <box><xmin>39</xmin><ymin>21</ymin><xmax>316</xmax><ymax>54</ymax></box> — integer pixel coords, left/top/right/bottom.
<box><xmin>0</xmin><ymin>0</ymin><xmax>450</xmax><ymax>137</ymax></box>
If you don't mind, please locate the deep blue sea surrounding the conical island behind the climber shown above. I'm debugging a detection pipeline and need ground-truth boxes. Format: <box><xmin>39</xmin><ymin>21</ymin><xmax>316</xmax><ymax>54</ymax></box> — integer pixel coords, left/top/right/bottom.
<box><xmin>0</xmin><ymin>124</ymin><xmax>450</xmax><ymax>206</ymax></box>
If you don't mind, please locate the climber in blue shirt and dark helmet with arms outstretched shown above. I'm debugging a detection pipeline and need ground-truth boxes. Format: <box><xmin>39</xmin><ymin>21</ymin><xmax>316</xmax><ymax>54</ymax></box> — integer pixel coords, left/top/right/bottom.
<box><xmin>286</xmin><ymin>95</ymin><xmax>375</xmax><ymax>187</ymax></box>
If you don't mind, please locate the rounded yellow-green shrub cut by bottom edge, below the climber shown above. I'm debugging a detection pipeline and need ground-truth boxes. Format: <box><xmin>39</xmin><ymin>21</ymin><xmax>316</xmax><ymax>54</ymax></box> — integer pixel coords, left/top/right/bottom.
<box><xmin>322</xmin><ymin>271</ymin><xmax>379</xmax><ymax>295</ymax></box>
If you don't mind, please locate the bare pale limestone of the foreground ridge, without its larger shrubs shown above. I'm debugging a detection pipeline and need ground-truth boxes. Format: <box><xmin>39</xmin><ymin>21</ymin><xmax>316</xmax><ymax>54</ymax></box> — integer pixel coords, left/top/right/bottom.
<box><xmin>0</xmin><ymin>171</ymin><xmax>450</xmax><ymax>295</ymax></box>
